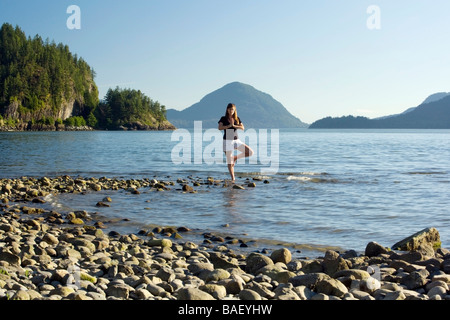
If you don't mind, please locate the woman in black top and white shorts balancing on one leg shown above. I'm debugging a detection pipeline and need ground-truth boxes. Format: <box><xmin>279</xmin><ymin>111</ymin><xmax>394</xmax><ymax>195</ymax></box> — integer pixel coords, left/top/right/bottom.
<box><xmin>219</xmin><ymin>103</ymin><xmax>253</xmax><ymax>182</ymax></box>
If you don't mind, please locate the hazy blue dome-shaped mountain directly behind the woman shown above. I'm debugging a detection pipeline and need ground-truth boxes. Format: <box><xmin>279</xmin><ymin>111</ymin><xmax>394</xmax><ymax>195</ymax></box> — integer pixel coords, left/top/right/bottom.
<box><xmin>167</xmin><ymin>82</ymin><xmax>308</xmax><ymax>129</ymax></box>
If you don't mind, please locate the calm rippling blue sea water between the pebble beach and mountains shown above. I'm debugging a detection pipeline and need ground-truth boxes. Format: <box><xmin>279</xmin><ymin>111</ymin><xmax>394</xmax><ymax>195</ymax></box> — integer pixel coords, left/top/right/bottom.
<box><xmin>0</xmin><ymin>129</ymin><xmax>450</xmax><ymax>253</ymax></box>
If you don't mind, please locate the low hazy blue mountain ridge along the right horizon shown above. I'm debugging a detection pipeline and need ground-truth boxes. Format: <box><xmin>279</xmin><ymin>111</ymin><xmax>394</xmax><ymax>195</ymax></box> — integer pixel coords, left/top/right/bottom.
<box><xmin>309</xmin><ymin>92</ymin><xmax>450</xmax><ymax>129</ymax></box>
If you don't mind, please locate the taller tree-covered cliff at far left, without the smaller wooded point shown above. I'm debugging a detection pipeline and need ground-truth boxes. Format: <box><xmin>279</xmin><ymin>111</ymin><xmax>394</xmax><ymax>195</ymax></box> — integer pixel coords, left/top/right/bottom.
<box><xmin>0</xmin><ymin>24</ymin><xmax>99</xmax><ymax>129</ymax></box>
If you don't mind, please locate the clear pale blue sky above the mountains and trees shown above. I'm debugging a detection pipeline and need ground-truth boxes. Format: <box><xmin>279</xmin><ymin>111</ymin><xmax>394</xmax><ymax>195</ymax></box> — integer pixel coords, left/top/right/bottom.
<box><xmin>0</xmin><ymin>0</ymin><xmax>450</xmax><ymax>123</ymax></box>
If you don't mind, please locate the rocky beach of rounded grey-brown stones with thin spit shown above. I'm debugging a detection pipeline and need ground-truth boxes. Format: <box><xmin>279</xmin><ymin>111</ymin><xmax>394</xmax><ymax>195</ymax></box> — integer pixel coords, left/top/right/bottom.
<box><xmin>0</xmin><ymin>176</ymin><xmax>450</xmax><ymax>301</ymax></box>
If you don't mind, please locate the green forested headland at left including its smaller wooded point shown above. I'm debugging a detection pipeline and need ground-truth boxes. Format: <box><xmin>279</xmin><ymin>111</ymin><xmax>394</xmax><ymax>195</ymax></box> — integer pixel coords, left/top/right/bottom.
<box><xmin>0</xmin><ymin>23</ymin><xmax>174</xmax><ymax>130</ymax></box>
